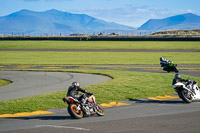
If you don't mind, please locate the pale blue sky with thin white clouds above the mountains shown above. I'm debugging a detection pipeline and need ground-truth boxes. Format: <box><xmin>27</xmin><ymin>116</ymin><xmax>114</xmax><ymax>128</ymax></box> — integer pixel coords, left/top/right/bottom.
<box><xmin>0</xmin><ymin>0</ymin><xmax>200</xmax><ymax>27</ymax></box>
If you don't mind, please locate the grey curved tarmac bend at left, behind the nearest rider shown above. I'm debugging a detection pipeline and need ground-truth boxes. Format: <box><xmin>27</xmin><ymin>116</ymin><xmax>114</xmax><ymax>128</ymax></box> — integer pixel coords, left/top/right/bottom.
<box><xmin>0</xmin><ymin>71</ymin><xmax>111</xmax><ymax>101</ymax></box>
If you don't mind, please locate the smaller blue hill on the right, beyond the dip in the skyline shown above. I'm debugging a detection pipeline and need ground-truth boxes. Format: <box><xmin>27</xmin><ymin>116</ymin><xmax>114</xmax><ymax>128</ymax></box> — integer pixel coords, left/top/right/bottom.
<box><xmin>138</xmin><ymin>13</ymin><xmax>200</xmax><ymax>31</ymax></box>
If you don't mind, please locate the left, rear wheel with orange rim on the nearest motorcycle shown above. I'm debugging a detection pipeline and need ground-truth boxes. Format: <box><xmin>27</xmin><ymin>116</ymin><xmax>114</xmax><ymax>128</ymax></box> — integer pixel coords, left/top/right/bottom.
<box><xmin>68</xmin><ymin>103</ymin><xmax>83</xmax><ymax>119</ymax></box>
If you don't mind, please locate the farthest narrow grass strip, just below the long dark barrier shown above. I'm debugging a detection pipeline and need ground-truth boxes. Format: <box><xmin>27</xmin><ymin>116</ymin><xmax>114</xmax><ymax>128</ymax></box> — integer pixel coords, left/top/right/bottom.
<box><xmin>0</xmin><ymin>41</ymin><xmax>200</xmax><ymax>49</ymax></box>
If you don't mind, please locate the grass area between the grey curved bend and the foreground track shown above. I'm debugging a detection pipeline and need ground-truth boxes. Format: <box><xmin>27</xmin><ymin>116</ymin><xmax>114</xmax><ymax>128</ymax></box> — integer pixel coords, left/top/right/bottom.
<box><xmin>0</xmin><ymin>70</ymin><xmax>200</xmax><ymax>114</ymax></box>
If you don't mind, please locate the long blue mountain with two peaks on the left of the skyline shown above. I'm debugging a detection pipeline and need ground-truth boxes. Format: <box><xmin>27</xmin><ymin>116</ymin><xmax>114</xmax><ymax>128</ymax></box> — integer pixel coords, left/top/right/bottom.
<box><xmin>0</xmin><ymin>9</ymin><xmax>135</xmax><ymax>35</ymax></box>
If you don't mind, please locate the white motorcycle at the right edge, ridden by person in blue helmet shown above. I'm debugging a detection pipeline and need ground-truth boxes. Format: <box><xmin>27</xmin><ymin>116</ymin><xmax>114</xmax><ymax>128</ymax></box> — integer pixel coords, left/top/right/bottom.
<box><xmin>173</xmin><ymin>80</ymin><xmax>200</xmax><ymax>103</ymax></box>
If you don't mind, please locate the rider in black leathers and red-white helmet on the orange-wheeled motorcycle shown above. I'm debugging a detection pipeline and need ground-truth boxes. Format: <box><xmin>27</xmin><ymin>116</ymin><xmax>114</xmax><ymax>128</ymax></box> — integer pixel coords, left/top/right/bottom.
<box><xmin>67</xmin><ymin>82</ymin><xmax>93</xmax><ymax>104</ymax></box>
